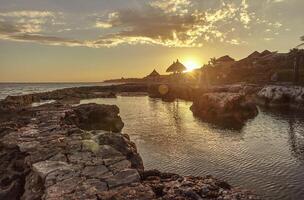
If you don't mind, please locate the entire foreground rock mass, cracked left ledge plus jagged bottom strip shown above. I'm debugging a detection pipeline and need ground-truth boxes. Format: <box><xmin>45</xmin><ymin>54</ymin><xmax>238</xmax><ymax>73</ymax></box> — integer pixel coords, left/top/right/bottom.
<box><xmin>0</xmin><ymin>103</ymin><xmax>258</xmax><ymax>200</ymax></box>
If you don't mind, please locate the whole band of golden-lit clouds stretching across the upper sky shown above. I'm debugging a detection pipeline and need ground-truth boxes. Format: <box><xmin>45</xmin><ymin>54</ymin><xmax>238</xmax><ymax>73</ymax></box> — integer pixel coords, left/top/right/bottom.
<box><xmin>0</xmin><ymin>0</ymin><xmax>282</xmax><ymax>48</ymax></box>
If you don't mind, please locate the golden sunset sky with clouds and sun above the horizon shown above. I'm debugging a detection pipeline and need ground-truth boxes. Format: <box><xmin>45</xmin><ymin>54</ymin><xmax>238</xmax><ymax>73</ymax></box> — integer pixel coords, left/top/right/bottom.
<box><xmin>0</xmin><ymin>0</ymin><xmax>304</xmax><ymax>82</ymax></box>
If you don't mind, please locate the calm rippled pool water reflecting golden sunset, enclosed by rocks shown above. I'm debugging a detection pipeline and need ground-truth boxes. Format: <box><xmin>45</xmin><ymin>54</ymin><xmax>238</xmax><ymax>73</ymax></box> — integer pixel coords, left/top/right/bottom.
<box><xmin>81</xmin><ymin>97</ymin><xmax>304</xmax><ymax>200</ymax></box>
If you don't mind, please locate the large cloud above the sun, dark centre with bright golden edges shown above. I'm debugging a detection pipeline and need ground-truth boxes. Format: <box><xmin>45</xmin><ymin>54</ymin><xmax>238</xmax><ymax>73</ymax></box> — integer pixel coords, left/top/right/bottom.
<box><xmin>91</xmin><ymin>0</ymin><xmax>264</xmax><ymax>47</ymax></box>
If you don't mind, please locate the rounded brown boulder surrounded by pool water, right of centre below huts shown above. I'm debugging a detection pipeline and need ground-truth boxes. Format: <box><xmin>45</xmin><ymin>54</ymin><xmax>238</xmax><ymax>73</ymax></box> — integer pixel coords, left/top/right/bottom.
<box><xmin>191</xmin><ymin>92</ymin><xmax>258</xmax><ymax>126</ymax></box>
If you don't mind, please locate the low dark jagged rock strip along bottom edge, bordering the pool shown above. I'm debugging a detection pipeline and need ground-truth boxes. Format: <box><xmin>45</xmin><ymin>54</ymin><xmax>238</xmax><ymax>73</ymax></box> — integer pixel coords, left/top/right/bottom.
<box><xmin>142</xmin><ymin>170</ymin><xmax>259</xmax><ymax>200</ymax></box>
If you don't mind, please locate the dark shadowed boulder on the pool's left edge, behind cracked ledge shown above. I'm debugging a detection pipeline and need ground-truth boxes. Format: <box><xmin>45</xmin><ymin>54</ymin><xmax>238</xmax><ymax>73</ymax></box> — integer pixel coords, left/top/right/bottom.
<box><xmin>65</xmin><ymin>104</ymin><xmax>124</xmax><ymax>132</ymax></box>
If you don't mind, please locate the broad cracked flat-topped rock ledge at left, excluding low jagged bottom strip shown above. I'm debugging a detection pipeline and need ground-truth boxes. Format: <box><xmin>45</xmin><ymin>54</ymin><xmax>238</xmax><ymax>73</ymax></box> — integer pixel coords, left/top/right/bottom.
<box><xmin>0</xmin><ymin>103</ymin><xmax>143</xmax><ymax>199</ymax></box>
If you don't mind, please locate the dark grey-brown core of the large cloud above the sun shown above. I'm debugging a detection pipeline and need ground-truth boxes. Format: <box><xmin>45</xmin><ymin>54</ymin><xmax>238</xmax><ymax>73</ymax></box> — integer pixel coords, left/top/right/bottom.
<box><xmin>108</xmin><ymin>8</ymin><xmax>197</xmax><ymax>40</ymax></box>
